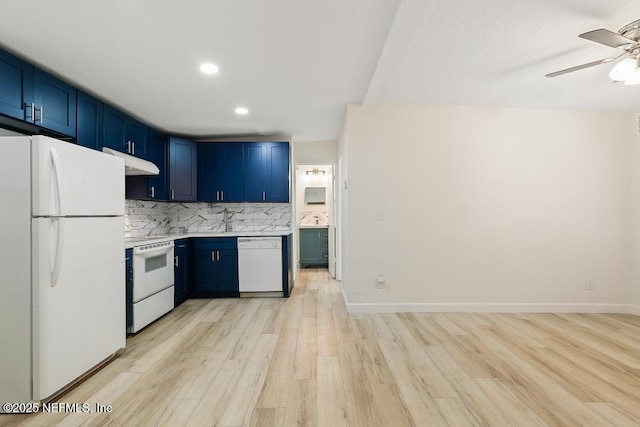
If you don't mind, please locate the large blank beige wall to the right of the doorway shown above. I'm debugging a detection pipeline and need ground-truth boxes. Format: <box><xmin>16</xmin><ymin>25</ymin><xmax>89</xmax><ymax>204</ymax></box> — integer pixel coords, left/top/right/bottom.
<box><xmin>338</xmin><ymin>105</ymin><xmax>640</xmax><ymax>311</ymax></box>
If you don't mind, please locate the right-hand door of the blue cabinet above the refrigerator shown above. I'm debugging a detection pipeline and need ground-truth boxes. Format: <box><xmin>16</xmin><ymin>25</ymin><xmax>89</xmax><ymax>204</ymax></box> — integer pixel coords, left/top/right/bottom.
<box><xmin>33</xmin><ymin>68</ymin><xmax>76</xmax><ymax>136</ymax></box>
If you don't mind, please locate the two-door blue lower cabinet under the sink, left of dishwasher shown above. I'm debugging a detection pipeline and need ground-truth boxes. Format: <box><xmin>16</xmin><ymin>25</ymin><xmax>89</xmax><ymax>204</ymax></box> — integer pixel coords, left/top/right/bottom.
<box><xmin>191</xmin><ymin>237</ymin><xmax>240</xmax><ymax>298</ymax></box>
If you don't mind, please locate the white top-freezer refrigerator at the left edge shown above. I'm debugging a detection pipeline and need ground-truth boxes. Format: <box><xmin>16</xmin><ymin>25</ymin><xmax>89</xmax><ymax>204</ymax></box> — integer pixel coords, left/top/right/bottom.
<box><xmin>0</xmin><ymin>136</ymin><xmax>126</xmax><ymax>412</ymax></box>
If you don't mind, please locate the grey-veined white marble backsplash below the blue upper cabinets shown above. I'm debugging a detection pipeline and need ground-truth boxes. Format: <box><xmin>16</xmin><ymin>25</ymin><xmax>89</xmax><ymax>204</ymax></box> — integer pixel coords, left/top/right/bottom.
<box><xmin>125</xmin><ymin>200</ymin><xmax>291</xmax><ymax>237</ymax></box>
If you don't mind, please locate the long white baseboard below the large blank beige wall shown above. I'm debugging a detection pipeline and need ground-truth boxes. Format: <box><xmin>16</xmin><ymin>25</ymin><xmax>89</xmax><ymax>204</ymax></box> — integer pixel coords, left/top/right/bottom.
<box><xmin>348</xmin><ymin>302</ymin><xmax>640</xmax><ymax>316</ymax></box>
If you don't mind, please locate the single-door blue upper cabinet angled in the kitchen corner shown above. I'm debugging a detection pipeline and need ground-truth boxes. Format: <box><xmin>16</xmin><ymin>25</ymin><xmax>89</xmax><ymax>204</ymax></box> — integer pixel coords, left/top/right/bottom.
<box><xmin>169</xmin><ymin>137</ymin><xmax>198</xmax><ymax>202</ymax></box>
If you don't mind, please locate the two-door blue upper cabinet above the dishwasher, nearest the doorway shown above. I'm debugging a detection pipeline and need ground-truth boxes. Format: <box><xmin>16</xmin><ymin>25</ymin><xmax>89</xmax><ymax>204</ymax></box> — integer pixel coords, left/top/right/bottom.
<box><xmin>244</xmin><ymin>142</ymin><xmax>289</xmax><ymax>203</ymax></box>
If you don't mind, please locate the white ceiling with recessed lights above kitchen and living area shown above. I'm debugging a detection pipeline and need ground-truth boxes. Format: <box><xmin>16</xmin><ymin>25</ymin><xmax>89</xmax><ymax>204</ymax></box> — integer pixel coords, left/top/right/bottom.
<box><xmin>0</xmin><ymin>0</ymin><xmax>640</xmax><ymax>141</ymax></box>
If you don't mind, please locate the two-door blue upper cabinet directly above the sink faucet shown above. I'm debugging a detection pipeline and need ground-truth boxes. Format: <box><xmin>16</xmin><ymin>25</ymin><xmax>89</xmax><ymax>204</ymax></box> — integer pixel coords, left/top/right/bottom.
<box><xmin>198</xmin><ymin>143</ymin><xmax>244</xmax><ymax>202</ymax></box>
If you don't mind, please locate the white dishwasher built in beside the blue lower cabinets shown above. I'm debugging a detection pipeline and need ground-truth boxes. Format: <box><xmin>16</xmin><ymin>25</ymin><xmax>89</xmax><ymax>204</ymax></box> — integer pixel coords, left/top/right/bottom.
<box><xmin>238</xmin><ymin>237</ymin><xmax>282</xmax><ymax>293</ymax></box>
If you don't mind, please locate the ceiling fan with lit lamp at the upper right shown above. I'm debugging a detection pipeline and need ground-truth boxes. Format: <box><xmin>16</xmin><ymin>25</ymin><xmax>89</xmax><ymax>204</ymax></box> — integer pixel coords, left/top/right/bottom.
<box><xmin>546</xmin><ymin>20</ymin><xmax>640</xmax><ymax>85</ymax></box>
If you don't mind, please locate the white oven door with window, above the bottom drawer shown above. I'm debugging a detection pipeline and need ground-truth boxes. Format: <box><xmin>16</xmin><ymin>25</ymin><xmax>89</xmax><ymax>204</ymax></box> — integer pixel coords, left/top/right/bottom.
<box><xmin>133</xmin><ymin>241</ymin><xmax>173</xmax><ymax>303</ymax></box>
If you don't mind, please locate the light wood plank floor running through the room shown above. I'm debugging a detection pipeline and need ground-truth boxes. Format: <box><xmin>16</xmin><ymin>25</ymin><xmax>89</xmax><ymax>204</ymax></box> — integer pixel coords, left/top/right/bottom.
<box><xmin>0</xmin><ymin>270</ymin><xmax>640</xmax><ymax>427</ymax></box>
